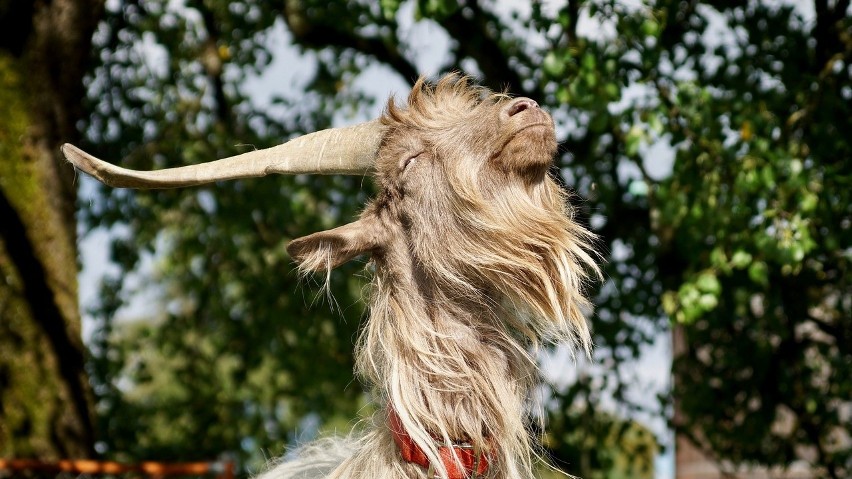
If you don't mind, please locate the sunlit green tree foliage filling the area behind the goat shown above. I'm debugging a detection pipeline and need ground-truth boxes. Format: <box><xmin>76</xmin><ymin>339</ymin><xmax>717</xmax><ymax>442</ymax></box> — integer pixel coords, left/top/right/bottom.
<box><xmin>76</xmin><ymin>0</ymin><xmax>852</xmax><ymax>477</ymax></box>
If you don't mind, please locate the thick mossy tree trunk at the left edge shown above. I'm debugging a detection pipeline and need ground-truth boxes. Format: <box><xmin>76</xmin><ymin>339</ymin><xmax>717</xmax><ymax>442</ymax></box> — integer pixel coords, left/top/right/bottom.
<box><xmin>0</xmin><ymin>0</ymin><xmax>103</xmax><ymax>459</ymax></box>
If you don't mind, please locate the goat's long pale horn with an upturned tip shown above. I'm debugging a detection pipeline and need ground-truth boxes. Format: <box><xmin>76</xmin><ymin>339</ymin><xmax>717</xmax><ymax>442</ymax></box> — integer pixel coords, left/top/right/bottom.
<box><xmin>62</xmin><ymin>120</ymin><xmax>384</xmax><ymax>188</ymax></box>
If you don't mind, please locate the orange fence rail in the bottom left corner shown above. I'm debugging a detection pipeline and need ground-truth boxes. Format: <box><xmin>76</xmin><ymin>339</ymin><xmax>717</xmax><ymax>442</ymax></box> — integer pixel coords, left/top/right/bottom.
<box><xmin>0</xmin><ymin>459</ymin><xmax>234</xmax><ymax>479</ymax></box>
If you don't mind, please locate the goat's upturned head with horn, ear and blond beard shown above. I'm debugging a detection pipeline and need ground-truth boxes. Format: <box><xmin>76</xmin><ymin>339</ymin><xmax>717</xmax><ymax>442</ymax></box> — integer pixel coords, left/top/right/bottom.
<box><xmin>63</xmin><ymin>75</ymin><xmax>596</xmax><ymax>347</ymax></box>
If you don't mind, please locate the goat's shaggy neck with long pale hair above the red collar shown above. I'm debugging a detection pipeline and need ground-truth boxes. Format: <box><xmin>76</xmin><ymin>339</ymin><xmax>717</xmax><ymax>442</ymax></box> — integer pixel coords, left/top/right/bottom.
<box><xmin>358</xmin><ymin>239</ymin><xmax>534</xmax><ymax>454</ymax></box>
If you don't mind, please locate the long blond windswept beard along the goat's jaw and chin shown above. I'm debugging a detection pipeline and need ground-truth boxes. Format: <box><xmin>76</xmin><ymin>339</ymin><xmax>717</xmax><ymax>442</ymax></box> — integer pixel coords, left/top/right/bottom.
<box><xmin>412</xmin><ymin>172</ymin><xmax>601</xmax><ymax>353</ymax></box>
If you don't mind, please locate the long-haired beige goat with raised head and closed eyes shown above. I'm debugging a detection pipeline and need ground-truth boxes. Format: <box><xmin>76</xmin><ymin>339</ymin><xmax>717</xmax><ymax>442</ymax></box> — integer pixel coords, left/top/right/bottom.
<box><xmin>63</xmin><ymin>75</ymin><xmax>600</xmax><ymax>479</ymax></box>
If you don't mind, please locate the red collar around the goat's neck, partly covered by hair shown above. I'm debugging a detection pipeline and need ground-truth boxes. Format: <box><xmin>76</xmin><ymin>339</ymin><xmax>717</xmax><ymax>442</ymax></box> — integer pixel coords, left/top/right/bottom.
<box><xmin>388</xmin><ymin>408</ymin><xmax>488</xmax><ymax>479</ymax></box>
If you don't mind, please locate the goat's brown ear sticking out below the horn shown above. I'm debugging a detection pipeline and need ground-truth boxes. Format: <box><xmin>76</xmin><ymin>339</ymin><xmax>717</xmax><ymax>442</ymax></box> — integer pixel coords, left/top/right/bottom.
<box><xmin>287</xmin><ymin>215</ymin><xmax>382</xmax><ymax>271</ymax></box>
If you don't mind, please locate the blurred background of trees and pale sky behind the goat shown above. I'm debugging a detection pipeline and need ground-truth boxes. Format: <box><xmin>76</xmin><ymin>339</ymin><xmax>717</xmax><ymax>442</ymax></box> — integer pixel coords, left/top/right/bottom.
<box><xmin>0</xmin><ymin>0</ymin><xmax>852</xmax><ymax>479</ymax></box>
